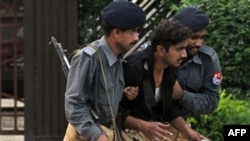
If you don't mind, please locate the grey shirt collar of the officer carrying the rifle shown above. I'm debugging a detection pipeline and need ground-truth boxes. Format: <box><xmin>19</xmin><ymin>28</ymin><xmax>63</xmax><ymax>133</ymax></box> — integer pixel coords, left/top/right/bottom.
<box><xmin>100</xmin><ymin>36</ymin><xmax>122</xmax><ymax>66</ymax></box>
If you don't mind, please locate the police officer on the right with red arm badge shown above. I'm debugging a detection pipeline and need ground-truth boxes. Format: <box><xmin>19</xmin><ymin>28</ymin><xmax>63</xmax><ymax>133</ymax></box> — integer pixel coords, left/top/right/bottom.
<box><xmin>163</xmin><ymin>7</ymin><xmax>222</xmax><ymax>141</ymax></box>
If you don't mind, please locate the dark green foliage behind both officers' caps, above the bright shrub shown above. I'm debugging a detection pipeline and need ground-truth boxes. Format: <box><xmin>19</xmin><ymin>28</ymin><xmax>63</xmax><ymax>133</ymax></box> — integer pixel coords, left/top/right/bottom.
<box><xmin>79</xmin><ymin>0</ymin><xmax>250</xmax><ymax>91</ymax></box>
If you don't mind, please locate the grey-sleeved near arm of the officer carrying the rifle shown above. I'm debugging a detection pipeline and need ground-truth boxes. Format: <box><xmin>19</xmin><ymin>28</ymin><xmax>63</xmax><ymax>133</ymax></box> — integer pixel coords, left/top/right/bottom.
<box><xmin>65</xmin><ymin>52</ymin><xmax>102</xmax><ymax>141</ymax></box>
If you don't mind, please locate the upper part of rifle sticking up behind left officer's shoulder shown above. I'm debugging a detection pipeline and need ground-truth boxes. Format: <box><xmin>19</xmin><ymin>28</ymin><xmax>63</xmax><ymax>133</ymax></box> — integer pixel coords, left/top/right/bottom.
<box><xmin>49</xmin><ymin>36</ymin><xmax>70</xmax><ymax>78</ymax></box>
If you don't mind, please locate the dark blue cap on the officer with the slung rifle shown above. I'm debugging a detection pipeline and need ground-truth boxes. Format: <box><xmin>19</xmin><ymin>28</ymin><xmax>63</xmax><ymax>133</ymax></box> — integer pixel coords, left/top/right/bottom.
<box><xmin>101</xmin><ymin>1</ymin><xmax>146</xmax><ymax>29</ymax></box>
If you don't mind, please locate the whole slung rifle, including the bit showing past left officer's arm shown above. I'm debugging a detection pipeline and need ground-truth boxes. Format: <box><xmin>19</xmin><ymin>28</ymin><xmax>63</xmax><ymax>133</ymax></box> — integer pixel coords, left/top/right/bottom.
<box><xmin>49</xmin><ymin>36</ymin><xmax>100</xmax><ymax>120</ymax></box>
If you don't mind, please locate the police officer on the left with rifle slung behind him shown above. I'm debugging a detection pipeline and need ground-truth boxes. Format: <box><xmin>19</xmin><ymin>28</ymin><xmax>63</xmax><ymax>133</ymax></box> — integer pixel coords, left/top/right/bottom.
<box><xmin>64</xmin><ymin>1</ymin><xmax>145</xmax><ymax>141</ymax></box>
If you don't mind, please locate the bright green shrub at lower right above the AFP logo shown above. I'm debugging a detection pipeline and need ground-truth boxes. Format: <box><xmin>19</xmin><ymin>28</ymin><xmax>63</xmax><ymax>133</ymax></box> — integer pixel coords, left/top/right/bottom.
<box><xmin>188</xmin><ymin>90</ymin><xmax>250</xmax><ymax>141</ymax></box>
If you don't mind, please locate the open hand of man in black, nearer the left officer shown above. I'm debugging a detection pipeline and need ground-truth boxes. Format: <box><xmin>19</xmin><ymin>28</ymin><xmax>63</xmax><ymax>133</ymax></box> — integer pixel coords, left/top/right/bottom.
<box><xmin>142</xmin><ymin>122</ymin><xmax>173</xmax><ymax>141</ymax></box>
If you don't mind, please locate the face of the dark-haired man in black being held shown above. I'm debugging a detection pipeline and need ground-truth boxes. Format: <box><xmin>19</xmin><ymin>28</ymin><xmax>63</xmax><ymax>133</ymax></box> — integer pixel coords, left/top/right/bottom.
<box><xmin>163</xmin><ymin>39</ymin><xmax>189</xmax><ymax>67</ymax></box>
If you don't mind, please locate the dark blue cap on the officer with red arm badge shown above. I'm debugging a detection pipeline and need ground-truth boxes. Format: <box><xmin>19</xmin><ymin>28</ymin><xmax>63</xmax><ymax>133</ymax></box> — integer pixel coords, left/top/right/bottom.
<box><xmin>173</xmin><ymin>7</ymin><xmax>209</xmax><ymax>32</ymax></box>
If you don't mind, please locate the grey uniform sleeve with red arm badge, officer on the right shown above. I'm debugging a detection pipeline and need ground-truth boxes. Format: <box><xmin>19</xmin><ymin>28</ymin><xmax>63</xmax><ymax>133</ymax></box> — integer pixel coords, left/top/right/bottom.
<box><xmin>181</xmin><ymin>54</ymin><xmax>222</xmax><ymax>114</ymax></box>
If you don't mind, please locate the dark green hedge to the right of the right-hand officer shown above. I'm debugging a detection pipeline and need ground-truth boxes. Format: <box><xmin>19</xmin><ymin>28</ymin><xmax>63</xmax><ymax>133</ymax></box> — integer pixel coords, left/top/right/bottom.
<box><xmin>167</xmin><ymin>0</ymin><xmax>250</xmax><ymax>90</ymax></box>
